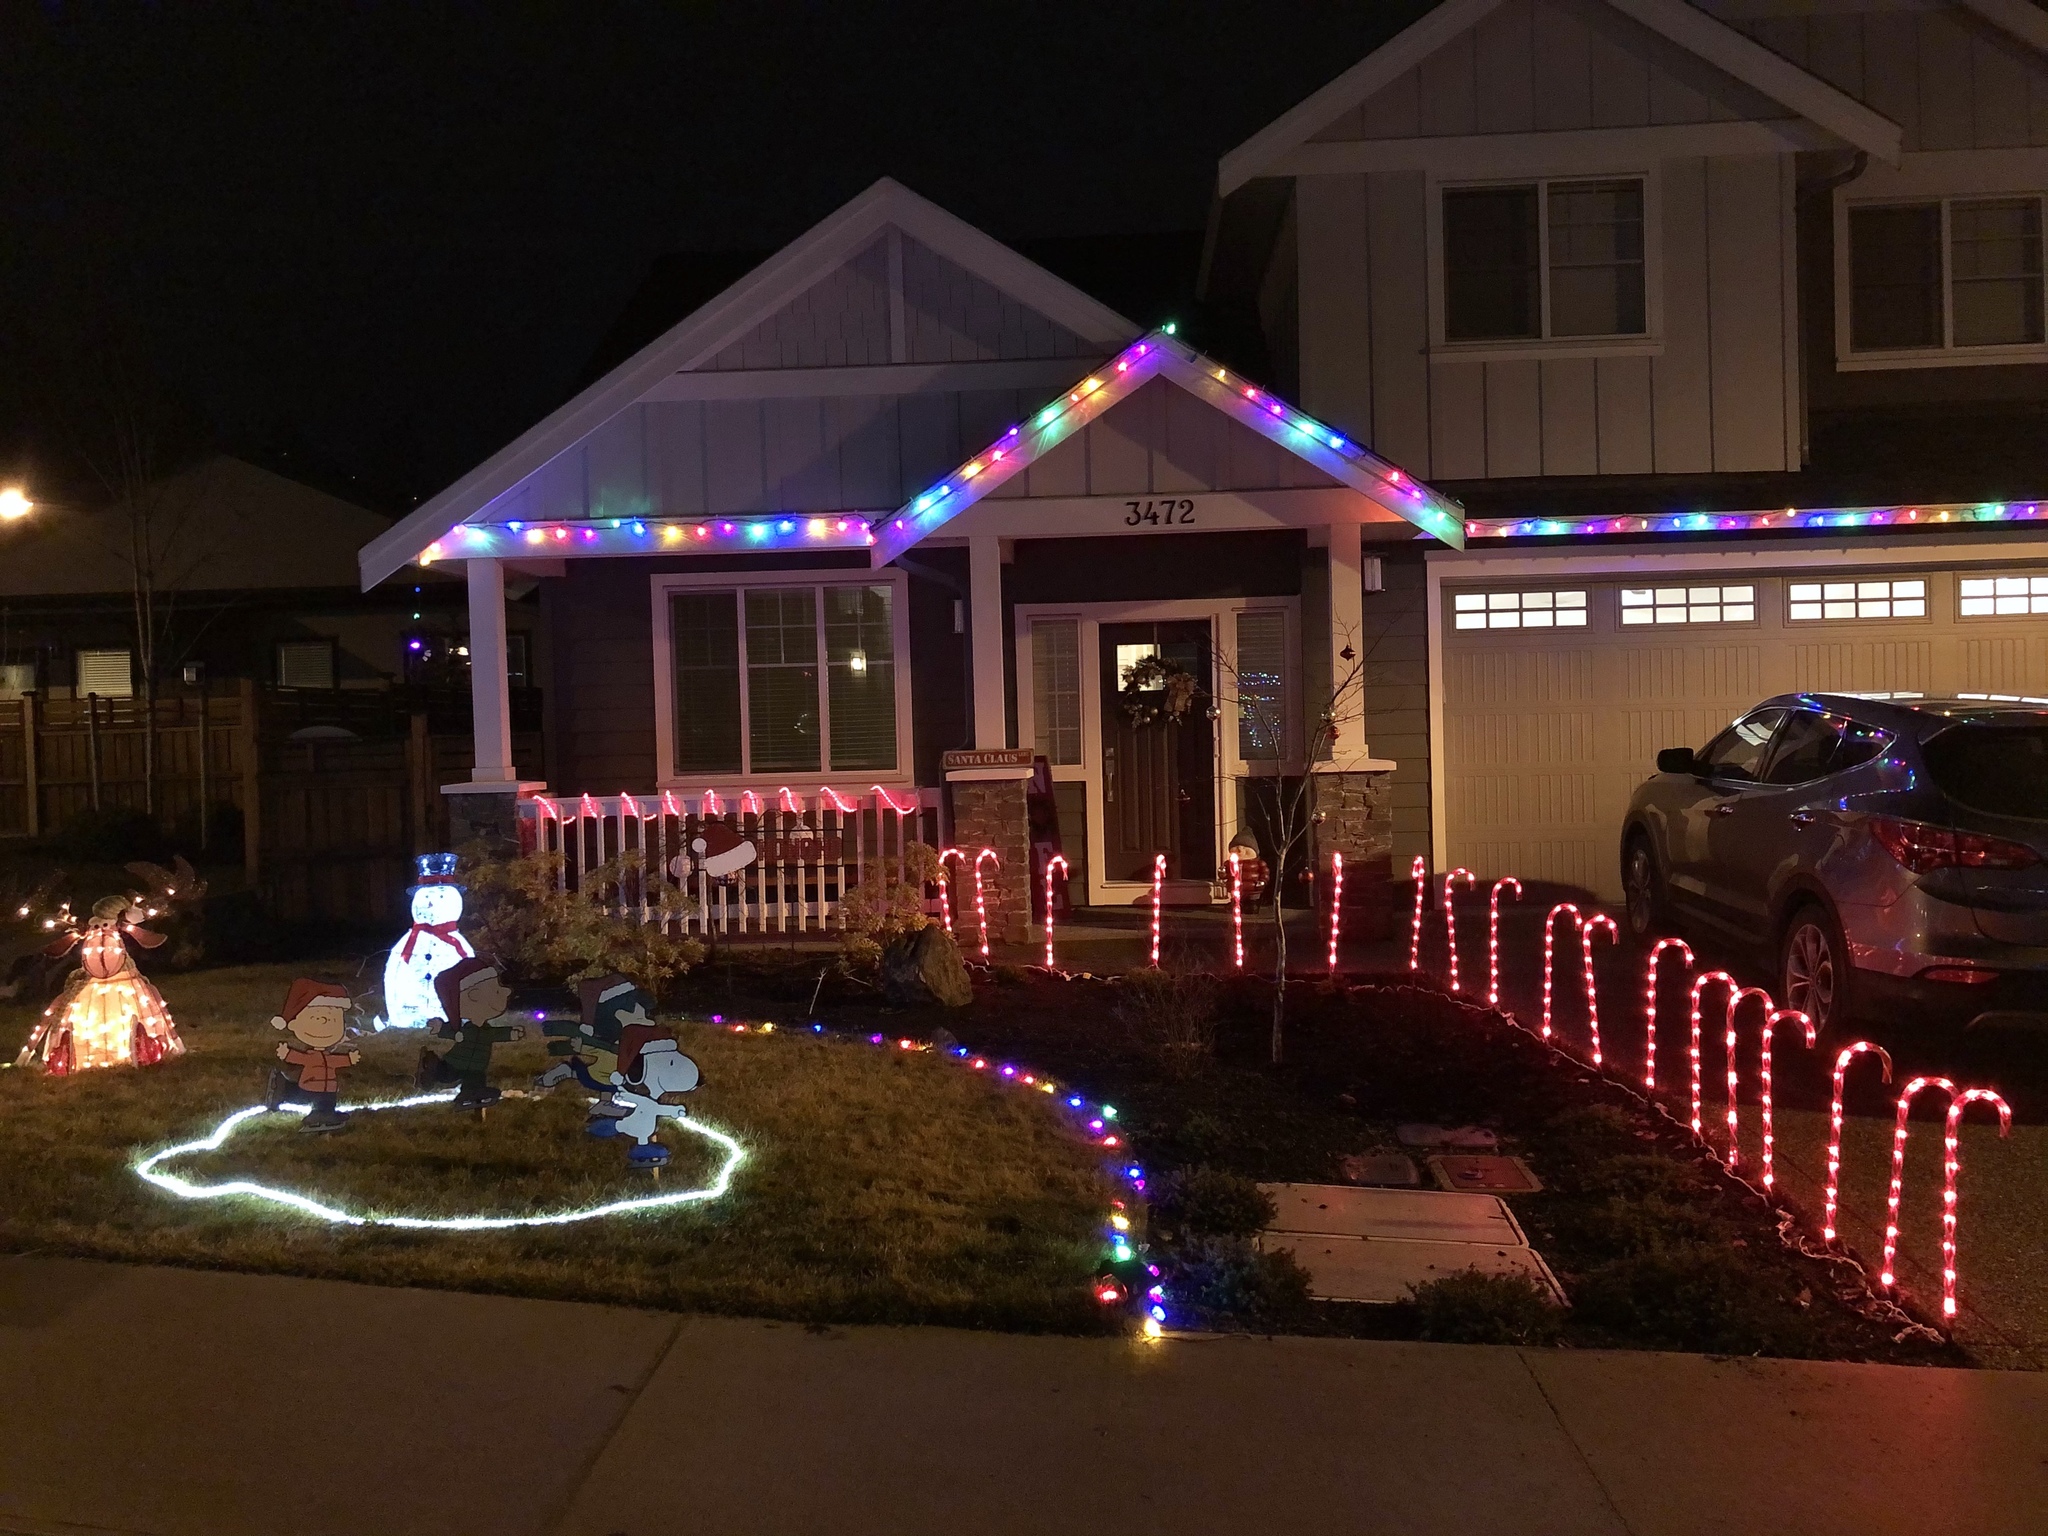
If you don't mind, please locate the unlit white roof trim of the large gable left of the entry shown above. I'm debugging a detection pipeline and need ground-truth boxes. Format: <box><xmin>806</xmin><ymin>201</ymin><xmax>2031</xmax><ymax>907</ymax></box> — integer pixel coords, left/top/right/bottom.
<box><xmin>358</xmin><ymin>176</ymin><xmax>1139</xmax><ymax>590</ymax></box>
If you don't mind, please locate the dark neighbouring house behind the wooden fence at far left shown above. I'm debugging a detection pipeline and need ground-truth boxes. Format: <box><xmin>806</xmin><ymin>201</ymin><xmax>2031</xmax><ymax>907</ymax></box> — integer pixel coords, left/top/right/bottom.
<box><xmin>0</xmin><ymin>455</ymin><xmax>535</xmax><ymax>698</ymax></box>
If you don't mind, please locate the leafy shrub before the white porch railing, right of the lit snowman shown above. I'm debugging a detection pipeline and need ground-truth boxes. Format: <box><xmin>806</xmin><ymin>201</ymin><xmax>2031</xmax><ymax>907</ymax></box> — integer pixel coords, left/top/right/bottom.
<box><xmin>461</xmin><ymin>846</ymin><xmax>705</xmax><ymax>993</ymax></box>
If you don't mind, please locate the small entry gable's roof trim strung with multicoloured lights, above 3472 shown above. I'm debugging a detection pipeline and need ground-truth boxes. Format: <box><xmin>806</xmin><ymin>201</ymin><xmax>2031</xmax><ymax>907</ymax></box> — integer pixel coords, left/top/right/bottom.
<box><xmin>868</xmin><ymin>330</ymin><xmax>1464</xmax><ymax>567</ymax></box>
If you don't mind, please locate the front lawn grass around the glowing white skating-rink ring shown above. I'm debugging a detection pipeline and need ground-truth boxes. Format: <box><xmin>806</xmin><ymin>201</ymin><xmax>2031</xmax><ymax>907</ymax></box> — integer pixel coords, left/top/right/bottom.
<box><xmin>0</xmin><ymin>967</ymin><xmax>1114</xmax><ymax>1331</ymax></box>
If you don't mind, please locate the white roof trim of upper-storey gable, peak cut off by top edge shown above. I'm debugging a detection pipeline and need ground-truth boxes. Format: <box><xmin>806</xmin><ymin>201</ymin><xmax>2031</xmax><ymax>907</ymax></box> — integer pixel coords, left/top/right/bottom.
<box><xmin>1217</xmin><ymin>0</ymin><xmax>1900</xmax><ymax>197</ymax></box>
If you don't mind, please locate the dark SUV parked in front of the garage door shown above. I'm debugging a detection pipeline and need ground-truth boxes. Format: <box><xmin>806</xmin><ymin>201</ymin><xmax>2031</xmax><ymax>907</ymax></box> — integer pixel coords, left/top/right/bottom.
<box><xmin>1622</xmin><ymin>694</ymin><xmax>2048</xmax><ymax>1026</ymax></box>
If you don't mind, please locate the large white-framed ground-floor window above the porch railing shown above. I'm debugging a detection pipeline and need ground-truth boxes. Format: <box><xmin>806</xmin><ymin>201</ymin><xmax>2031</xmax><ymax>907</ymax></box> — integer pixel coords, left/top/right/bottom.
<box><xmin>668</xmin><ymin>584</ymin><xmax>897</xmax><ymax>774</ymax></box>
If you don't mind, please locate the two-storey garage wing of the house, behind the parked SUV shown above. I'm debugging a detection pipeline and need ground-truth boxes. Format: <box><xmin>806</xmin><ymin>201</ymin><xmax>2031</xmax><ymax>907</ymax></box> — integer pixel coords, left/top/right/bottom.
<box><xmin>1204</xmin><ymin>0</ymin><xmax>2048</xmax><ymax>895</ymax></box>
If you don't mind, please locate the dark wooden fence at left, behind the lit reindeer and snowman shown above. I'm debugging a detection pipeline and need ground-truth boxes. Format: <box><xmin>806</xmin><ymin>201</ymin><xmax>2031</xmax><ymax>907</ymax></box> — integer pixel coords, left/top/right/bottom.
<box><xmin>0</xmin><ymin>682</ymin><xmax>541</xmax><ymax>924</ymax></box>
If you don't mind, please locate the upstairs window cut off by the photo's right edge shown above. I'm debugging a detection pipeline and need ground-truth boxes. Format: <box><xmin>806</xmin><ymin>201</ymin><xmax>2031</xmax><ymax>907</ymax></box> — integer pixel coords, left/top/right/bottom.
<box><xmin>1849</xmin><ymin>197</ymin><xmax>2048</xmax><ymax>352</ymax></box>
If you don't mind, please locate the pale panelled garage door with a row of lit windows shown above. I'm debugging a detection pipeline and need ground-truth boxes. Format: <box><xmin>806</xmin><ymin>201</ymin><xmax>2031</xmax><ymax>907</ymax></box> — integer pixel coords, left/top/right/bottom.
<box><xmin>1432</xmin><ymin>551</ymin><xmax>2048</xmax><ymax>901</ymax></box>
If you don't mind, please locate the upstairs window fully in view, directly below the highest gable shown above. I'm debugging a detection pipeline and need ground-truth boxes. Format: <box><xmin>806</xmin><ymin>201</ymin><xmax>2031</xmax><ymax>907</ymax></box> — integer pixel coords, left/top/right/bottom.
<box><xmin>1444</xmin><ymin>176</ymin><xmax>1649</xmax><ymax>342</ymax></box>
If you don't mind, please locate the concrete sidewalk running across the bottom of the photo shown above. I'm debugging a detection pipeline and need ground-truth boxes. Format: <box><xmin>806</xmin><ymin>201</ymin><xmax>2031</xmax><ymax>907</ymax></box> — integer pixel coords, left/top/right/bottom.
<box><xmin>0</xmin><ymin>1260</ymin><xmax>2048</xmax><ymax>1536</ymax></box>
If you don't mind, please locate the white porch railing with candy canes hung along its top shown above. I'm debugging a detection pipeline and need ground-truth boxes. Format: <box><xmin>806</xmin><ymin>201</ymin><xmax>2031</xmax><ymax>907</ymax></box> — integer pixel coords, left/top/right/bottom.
<box><xmin>518</xmin><ymin>784</ymin><xmax>946</xmax><ymax>936</ymax></box>
